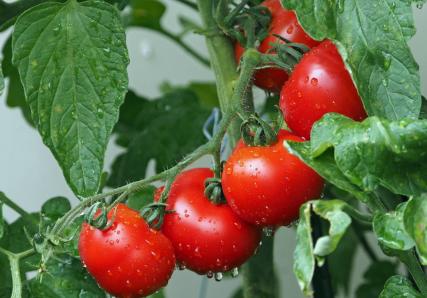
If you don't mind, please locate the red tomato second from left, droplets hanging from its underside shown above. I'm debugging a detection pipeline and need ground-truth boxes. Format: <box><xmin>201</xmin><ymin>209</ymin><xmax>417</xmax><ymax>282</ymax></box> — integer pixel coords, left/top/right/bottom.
<box><xmin>162</xmin><ymin>168</ymin><xmax>261</xmax><ymax>274</ymax></box>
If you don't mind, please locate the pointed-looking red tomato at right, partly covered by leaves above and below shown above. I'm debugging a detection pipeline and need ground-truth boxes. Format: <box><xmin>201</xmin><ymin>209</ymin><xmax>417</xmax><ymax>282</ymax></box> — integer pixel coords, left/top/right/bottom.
<box><xmin>280</xmin><ymin>40</ymin><xmax>366</xmax><ymax>140</ymax></box>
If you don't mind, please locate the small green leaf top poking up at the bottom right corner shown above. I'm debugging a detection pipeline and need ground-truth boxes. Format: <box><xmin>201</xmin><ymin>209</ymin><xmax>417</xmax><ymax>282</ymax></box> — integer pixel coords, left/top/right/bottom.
<box><xmin>379</xmin><ymin>275</ymin><xmax>423</xmax><ymax>298</ymax></box>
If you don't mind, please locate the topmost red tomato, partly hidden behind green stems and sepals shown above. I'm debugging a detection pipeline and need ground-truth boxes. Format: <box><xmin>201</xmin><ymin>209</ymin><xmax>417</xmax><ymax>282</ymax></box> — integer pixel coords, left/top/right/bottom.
<box><xmin>235</xmin><ymin>0</ymin><xmax>319</xmax><ymax>92</ymax></box>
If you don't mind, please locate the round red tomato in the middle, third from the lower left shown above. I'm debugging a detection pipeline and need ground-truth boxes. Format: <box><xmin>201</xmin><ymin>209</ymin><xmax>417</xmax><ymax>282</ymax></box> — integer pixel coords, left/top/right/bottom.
<box><xmin>222</xmin><ymin>130</ymin><xmax>323</xmax><ymax>227</ymax></box>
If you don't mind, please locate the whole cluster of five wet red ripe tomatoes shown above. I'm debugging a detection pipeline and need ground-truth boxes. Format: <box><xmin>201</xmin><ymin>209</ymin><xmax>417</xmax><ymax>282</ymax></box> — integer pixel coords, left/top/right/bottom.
<box><xmin>79</xmin><ymin>0</ymin><xmax>366</xmax><ymax>297</ymax></box>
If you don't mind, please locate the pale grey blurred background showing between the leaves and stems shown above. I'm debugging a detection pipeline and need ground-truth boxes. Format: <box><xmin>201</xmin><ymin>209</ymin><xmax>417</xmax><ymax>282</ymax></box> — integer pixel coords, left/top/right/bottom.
<box><xmin>0</xmin><ymin>1</ymin><xmax>427</xmax><ymax>298</ymax></box>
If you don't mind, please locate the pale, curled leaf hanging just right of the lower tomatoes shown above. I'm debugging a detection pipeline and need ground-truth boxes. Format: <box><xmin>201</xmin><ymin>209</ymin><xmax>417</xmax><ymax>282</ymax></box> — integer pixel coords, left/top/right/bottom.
<box><xmin>294</xmin><ymin>200</ymin><xmax>351</xmax><ymax>295</ymax></box>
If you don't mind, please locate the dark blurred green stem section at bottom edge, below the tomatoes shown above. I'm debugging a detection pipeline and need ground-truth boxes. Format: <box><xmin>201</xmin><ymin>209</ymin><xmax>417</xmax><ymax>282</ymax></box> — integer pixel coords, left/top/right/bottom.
<box><xmin>242</xmin><ymin>236</ymin><xmax>279</xmax><ymax>298</ymax></box>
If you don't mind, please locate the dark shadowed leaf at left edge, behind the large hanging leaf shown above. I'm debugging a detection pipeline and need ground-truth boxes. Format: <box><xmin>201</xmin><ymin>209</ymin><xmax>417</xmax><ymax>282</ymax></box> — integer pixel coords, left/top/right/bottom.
<box><xmin>3</xmin><ymin>36</ymin><xmax>34</xmax><ymax>126</ymax></box>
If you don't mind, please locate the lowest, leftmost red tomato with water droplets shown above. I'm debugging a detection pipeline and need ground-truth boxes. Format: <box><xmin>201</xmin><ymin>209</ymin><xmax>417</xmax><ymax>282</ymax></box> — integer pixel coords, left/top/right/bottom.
<box><xmin>79</xmin><ymin>204</ymin><xmax>175</xmax><ymax>298</ymax></box>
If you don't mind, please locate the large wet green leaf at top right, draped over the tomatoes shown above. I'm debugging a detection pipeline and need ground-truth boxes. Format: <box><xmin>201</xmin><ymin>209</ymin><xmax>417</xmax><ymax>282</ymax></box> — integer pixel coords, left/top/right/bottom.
<box><xmin>282</xmin><ymin>0</ymin><xmax>421</xmax><ymax>120</ymax></box>
